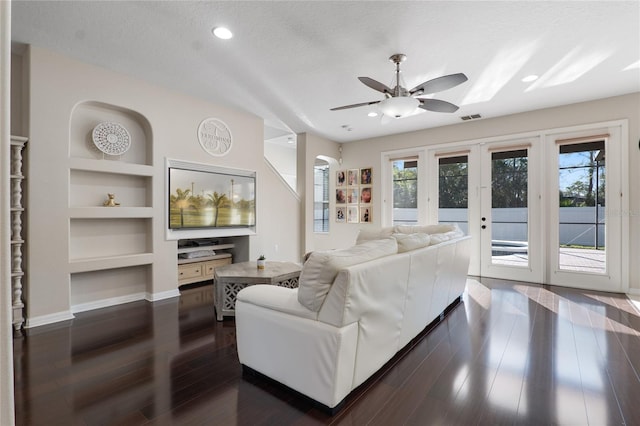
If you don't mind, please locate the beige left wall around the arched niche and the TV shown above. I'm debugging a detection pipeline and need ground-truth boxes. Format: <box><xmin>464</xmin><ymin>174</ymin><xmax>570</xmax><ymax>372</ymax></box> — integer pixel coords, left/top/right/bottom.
<box><xmin>17</xmin><ymin>47</ymin><xmax>300</xmax><ymax>323</ymax></box>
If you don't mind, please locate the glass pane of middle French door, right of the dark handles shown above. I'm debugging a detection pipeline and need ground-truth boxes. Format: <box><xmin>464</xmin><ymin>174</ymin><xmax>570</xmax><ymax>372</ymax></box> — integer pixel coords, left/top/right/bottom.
<box><xmin>490</xmin><ymin>149</ymin><xmax>529</xmax><ymax>267</ymax></box>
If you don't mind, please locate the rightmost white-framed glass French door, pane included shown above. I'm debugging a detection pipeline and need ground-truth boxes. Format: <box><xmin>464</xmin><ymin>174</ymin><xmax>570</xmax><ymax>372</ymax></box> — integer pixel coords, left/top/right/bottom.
<box><xmin>546</xmin><ymin>126</ymin><xmax>629</xmax><ymax>292</ymax></box>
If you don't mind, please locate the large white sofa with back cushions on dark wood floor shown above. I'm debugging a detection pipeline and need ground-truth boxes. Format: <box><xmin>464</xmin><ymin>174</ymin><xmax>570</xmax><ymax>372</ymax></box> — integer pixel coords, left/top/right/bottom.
<box><xmin>236</xmin><ymin>225</ymin><xmax>470</xmax><ymax>412</ymax></box>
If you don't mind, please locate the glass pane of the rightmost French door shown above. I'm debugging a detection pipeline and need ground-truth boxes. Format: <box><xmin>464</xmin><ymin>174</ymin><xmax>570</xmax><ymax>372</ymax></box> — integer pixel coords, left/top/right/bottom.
<box><xmin>558</xmin><ymin>141</ymin><xmax>607</xmax><ymax>274</ymax></box>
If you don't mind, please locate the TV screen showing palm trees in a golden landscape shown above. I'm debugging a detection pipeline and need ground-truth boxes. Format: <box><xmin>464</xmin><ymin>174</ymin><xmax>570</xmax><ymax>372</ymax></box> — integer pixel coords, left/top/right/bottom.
<box><xmin>169</xmin><ymin>168</ymin><xmax>256</xmax><ymax>229</ymax></box>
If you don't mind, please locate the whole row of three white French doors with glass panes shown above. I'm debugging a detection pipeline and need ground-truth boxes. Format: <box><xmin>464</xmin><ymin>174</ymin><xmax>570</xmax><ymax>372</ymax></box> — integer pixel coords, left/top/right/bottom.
<box><xmin>427</xmin><ymin>121</ymin><xmax>628</xmax><ymax>291</ymax></box>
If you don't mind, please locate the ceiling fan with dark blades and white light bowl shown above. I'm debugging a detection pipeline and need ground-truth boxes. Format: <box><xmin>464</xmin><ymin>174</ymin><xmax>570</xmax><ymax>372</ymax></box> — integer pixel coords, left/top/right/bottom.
<box><xmin>331</xmin><ymin>53</ymin><xmax>468</xmax><ymax>118</ymax></box>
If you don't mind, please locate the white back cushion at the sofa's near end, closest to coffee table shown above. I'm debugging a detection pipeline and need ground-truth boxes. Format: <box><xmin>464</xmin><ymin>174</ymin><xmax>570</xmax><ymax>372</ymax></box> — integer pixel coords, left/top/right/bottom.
<box><xmin>298</xmin><ymin>238</ymin><xmax>398</xmax><ymax>312</ymax></box>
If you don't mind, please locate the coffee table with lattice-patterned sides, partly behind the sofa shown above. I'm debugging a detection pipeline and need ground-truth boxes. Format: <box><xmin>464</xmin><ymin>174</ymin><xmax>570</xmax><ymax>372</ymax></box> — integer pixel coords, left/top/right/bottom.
<box><xmin>213</xmin><ymin>261</ymin><xmax>302</xmax><ymax>321</ymax></box>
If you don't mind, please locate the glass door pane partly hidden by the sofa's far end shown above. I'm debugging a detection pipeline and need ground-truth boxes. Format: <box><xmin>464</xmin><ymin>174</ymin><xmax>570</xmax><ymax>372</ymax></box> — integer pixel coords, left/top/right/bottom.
<box><xmin>438</xmin><ymin>155</ymin><xmax>469</xmax><ymax>235</ymax></box>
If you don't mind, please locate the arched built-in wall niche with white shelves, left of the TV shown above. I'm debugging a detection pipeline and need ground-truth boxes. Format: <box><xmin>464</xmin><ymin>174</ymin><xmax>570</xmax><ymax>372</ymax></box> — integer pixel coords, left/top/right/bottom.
<box><xmin>68</xmin><ymin>102</ymin><xmax>154</xmax><ymax>312</ymax></box>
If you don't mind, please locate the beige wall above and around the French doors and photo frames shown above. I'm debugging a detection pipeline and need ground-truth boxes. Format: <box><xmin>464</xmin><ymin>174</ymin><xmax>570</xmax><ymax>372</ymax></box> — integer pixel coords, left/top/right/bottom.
<box><xmin>327</xmin><ymin>93</ymin><xmax>640</xmax><ymax>294</ymax></box>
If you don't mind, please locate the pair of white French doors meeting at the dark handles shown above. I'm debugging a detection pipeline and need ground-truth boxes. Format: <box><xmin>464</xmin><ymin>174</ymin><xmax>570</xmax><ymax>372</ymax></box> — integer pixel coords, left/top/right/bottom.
<box><xmin>428</xmin><ymin>140</ymin><xmax>543</xmax><ymax>282</ymax></box>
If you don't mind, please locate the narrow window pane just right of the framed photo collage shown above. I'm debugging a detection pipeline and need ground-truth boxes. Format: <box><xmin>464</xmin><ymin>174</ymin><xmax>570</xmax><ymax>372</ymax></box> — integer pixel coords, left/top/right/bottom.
<box><xmin>391</xmin><ymin>157</ymin><xmax>418</xmax><ymax>225</ymax></box>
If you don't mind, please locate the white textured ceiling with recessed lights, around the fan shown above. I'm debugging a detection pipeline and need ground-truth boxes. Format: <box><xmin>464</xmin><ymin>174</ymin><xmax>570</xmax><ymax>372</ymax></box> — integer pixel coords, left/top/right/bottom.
<box><xmin>12</xmin><ymin>0</ymin><xmax>640</xmax><ymax>142</ymax></box>
